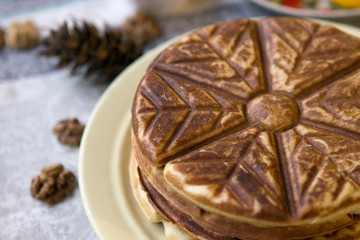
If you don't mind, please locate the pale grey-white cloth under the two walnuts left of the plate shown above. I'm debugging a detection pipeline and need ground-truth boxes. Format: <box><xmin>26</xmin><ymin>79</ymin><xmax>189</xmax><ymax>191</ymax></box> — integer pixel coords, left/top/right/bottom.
<box><xmin>0</xmin><ymin>70</ymin><xmax>105</xmax><ymax>240</ymax></box>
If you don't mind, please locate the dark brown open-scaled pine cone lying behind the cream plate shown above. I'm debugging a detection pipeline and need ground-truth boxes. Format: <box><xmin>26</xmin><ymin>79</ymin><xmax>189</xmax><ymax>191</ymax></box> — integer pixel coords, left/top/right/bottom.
<box><xmin>41</xmin><ymin>19</ymin><xmax>142</xmax><ymax>80</ymax></box>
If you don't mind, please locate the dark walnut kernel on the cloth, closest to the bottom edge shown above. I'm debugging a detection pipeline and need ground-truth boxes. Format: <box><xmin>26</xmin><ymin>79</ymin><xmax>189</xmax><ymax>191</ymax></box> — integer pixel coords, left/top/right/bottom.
<box><xmin>30</xmin><ymin>164</ymin><xmax>75</xmax><ymax>204</ymax></box>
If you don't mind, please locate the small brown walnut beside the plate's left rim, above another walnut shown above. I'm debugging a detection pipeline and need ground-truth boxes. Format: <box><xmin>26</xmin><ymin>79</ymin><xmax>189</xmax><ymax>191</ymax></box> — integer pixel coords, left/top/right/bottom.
<box><xmin>53</xmin><ymin>118</ymin><xmax>85</xmax><ymax>146</ymax></box>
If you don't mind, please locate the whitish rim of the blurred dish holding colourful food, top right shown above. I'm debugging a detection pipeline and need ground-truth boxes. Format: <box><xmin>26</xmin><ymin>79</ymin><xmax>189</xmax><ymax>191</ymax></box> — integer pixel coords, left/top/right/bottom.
<box><xmin>251</xmin><ymin>0</ymin><xmax>360</xmax><ymax>19</ymax></box>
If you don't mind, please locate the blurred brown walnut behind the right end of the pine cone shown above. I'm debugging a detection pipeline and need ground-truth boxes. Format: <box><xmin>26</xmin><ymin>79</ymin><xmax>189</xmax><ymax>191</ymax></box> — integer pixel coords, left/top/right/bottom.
<box><xmin>120</xmin><ymin>12</ymin><xmax>160</xmax><ymax>49</ymax></box>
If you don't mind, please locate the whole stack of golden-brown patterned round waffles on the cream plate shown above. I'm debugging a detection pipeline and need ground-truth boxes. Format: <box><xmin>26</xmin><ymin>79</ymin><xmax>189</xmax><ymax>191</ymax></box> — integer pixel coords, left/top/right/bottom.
<box><xmin>131</xmin><ymin>18</ymin><xmax>360</xmax><ymax>240</ymax></box>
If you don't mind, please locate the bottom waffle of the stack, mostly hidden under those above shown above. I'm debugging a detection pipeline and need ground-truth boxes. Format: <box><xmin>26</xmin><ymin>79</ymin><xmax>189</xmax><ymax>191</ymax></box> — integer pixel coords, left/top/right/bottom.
<box><xmin>130</xmin><ymin>155</ymin><xmax>360</xmax><ymax>240</ymax></box>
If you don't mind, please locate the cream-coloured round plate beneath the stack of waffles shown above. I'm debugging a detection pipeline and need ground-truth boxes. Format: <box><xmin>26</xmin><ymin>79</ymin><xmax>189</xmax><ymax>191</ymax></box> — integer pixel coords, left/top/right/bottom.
<box><xmin>79</xmin><ymin>20</ymin><xmax>360</xmax><ymax>240</ymax></box>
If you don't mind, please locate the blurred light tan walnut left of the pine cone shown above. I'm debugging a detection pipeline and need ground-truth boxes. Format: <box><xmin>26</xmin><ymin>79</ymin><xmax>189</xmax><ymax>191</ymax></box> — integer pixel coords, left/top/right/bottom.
<box><xmin>5</xmin><ymin>21</ymin><xmax>40</xmax><ymax>49</ymax></box>
